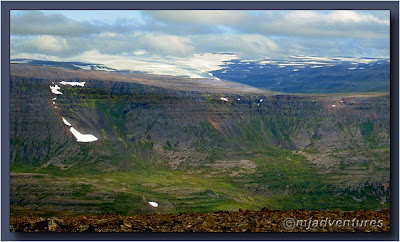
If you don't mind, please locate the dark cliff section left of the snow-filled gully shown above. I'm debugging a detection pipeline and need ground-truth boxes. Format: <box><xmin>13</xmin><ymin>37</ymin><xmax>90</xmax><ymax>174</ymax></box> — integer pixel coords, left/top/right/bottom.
<box><xmin>10</xmin><ymin>77</ymin><xmax>80</xmax><ymax>164</ymax></box>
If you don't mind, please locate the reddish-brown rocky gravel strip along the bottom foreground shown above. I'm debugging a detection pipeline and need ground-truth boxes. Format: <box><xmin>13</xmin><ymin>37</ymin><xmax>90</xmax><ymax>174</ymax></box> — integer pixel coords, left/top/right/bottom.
<box><xmin>10</xmin><ymin>209</ymin><xmax>390</xmax><ymax>232</ymax></box>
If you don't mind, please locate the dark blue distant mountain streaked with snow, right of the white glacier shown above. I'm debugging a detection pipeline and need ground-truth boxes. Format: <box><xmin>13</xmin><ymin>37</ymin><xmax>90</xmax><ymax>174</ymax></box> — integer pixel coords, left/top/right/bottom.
<box><xmin>212</xmin><ymin>57</ymin><xmax>390</xmax><ymax>93</ymax></box>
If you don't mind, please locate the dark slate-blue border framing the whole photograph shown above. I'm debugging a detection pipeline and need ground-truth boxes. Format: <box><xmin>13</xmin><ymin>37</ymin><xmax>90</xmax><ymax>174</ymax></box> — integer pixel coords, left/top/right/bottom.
<box><xmin>1</xmin><ymin>1</ymin><xmax>399</xmax><ymax>241</ymax></box>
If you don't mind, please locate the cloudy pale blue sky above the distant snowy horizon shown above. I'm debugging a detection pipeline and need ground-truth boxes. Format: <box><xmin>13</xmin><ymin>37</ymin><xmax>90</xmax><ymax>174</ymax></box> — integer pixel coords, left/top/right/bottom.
<box><xmin>11</xmin><ymin>10</ymin><xmax>390</xmax><ymax>75</ymax></box>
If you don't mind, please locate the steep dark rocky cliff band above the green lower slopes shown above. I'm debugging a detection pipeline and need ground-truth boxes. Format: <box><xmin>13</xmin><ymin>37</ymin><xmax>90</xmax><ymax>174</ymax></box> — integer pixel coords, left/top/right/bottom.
<box><xmin>11</xmin><ymin>73</ymin><xmax>390</xmax><ymax>167</ymax></box>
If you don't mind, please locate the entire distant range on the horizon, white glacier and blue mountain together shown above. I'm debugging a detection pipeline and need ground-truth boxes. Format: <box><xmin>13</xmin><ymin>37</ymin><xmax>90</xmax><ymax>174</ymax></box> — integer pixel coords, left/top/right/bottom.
<box><xmin>11</xmin><ymin>56</ymin><xmax>390</xmax><ymax>94</ymax></box>
